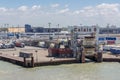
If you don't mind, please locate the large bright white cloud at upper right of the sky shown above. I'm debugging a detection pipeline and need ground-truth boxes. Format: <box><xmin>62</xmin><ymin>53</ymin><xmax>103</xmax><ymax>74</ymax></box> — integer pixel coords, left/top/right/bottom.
<box><xmin>73</xmin><ymin>3</ymin><xmax>120</xmax><ymax>17</ymax></box>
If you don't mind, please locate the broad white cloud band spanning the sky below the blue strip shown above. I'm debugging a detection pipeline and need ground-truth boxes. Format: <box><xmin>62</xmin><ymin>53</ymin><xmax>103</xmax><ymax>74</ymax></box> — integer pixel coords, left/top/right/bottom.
<box><xmin>0</xmin><ymin>3</ymin><xmax>120</xmax><ymax>25</ymax></box>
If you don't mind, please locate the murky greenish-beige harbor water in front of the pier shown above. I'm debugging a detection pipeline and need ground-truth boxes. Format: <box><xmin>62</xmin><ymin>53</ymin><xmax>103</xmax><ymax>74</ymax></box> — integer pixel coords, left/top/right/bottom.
<box><xmin>0</xmin><ymin>61</ymin><xmax>120</xmax><ymax>80</ymax></box>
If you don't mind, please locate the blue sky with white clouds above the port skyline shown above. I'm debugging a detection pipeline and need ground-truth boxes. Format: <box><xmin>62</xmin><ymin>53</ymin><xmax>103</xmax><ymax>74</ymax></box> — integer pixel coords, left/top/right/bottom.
<box><xmin>0</xmin><ymin>0</ymin><xmax>120</xmax><ymax>27</ymax></box>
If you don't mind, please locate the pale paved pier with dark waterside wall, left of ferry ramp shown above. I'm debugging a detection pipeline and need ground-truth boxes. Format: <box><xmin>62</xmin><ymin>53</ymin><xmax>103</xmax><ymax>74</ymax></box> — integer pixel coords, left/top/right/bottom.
<box><xmin>0</xmin><ymin>47</ymin><xmax>77</xmax><ymax>68</ymax></box>
